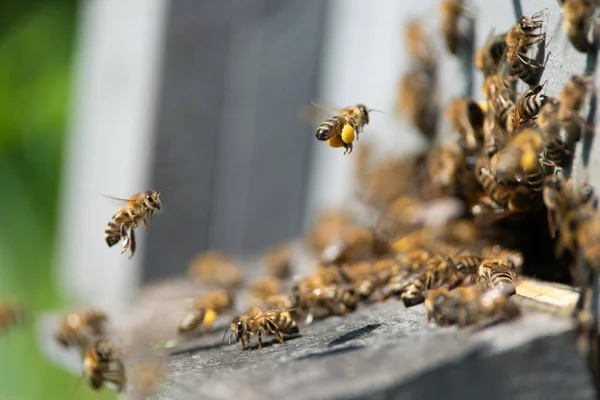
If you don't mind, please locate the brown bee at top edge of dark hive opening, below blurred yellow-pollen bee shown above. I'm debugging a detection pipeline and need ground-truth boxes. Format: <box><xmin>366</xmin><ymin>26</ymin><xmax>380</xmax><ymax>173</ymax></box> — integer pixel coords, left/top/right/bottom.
<box><xmin>472</xmin><ymin>157</ymin><xmax>529</xmax><ymax>216</ymax></box>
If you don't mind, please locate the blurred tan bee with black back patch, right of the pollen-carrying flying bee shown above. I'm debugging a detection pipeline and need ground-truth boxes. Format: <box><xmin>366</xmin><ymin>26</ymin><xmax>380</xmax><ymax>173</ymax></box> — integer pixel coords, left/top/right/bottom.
<box><xmin>445</xmin><ymin>97</ymin><xmax>485</xmax><ymax>152</ymax></box>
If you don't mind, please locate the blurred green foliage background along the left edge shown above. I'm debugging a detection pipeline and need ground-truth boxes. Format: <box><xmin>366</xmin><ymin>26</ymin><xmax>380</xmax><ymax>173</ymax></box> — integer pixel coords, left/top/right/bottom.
<box><xmin>0</xmin><ymin>0</ymin><xmax>115</xmax><ymax>400</ymax></box>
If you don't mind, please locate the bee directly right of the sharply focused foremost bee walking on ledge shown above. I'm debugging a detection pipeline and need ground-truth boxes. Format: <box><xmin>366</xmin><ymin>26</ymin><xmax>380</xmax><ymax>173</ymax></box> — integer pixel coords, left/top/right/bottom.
<box><xmin>292</xmin><ymin>282</ymin><xmax>358</xmax><ymax>325</ymax></box>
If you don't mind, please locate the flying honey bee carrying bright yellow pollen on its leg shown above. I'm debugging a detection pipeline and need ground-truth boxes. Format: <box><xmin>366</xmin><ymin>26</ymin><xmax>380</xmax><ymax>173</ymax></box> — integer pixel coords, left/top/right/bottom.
<box><xmin>315</xmin><ymin>104</ymin><xmax>375</xmax><ymax>154</ymax></box>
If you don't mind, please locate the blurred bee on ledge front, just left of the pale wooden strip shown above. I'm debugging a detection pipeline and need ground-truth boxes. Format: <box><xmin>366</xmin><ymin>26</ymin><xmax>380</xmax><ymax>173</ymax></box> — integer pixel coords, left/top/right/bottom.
<box><xmin>425</xmin><ymin>285</ymin><xmax>520</xmax><ymax>327</ymax></box>
